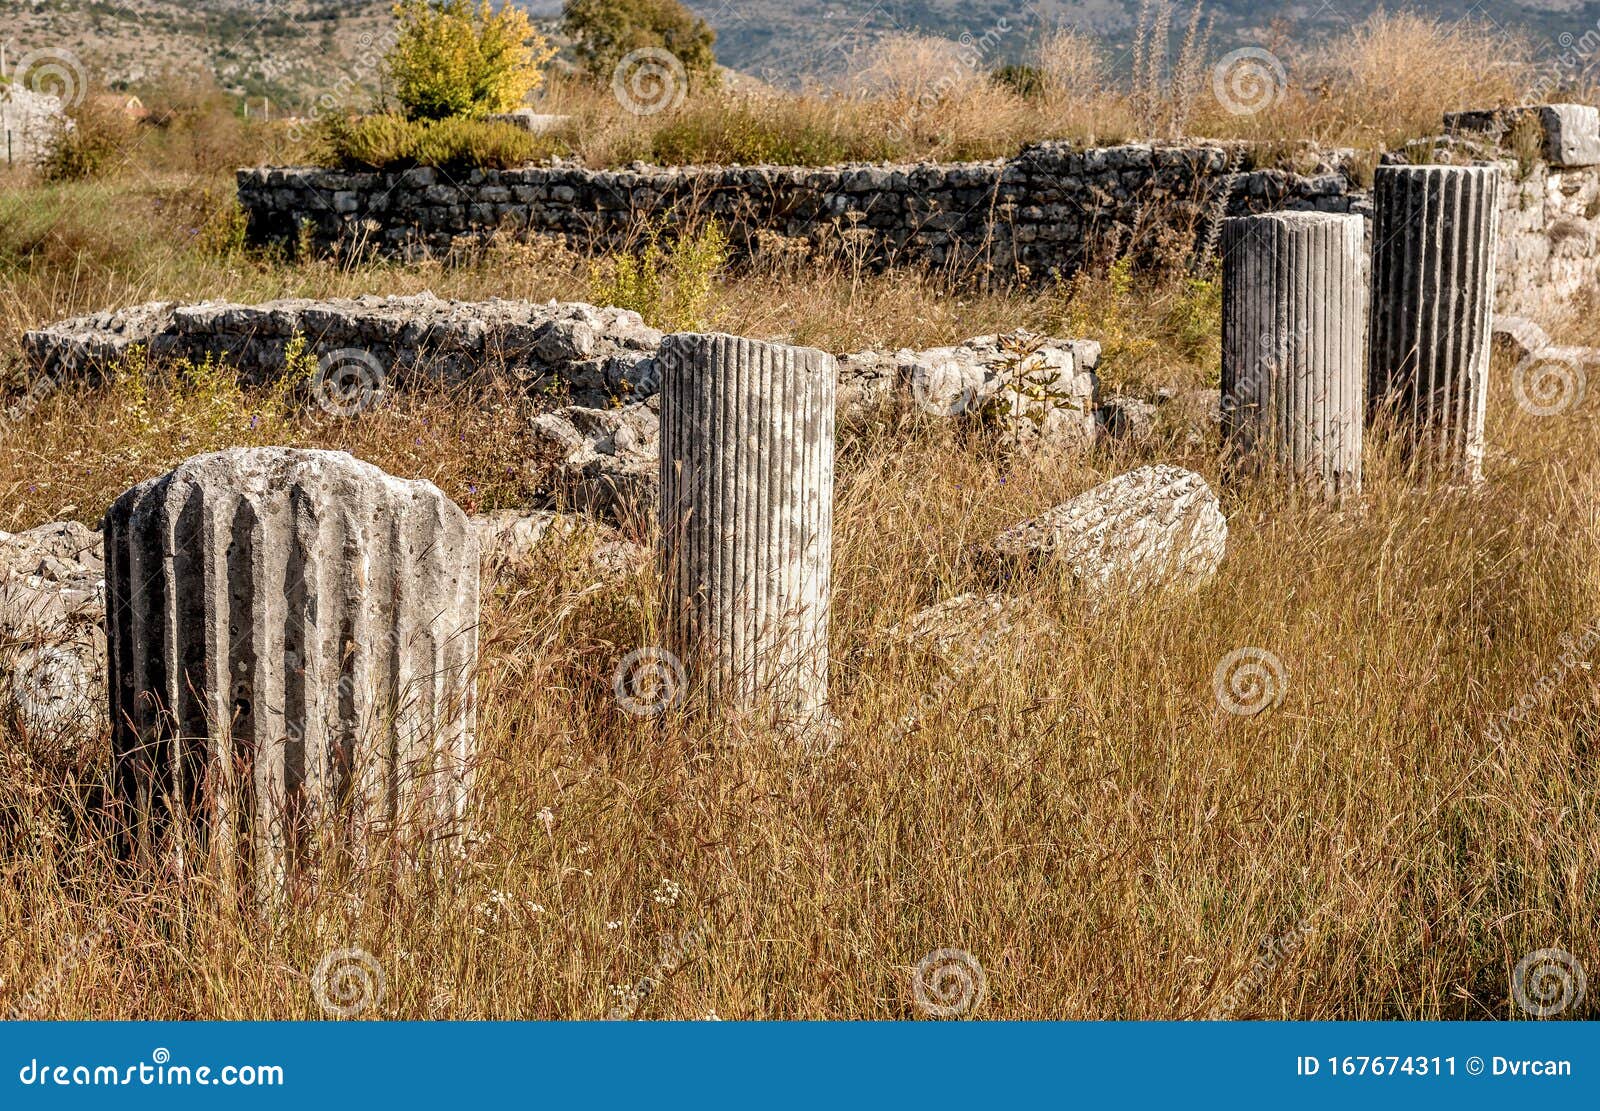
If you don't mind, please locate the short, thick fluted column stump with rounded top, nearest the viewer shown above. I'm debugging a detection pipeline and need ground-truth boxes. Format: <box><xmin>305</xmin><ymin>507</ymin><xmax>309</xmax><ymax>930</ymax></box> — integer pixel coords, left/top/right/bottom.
<box><xmin>106</xmin><ymin>448</ymin><xmax>478</xmax><ymax>887</ymax></box>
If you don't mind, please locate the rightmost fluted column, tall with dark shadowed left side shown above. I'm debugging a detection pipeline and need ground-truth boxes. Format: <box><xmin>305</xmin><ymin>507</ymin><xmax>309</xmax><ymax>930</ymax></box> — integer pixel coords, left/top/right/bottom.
<box><xmin>1366</xmin><ymin>166</ymin><xmax>1501</xmax><ymax>479</ymax></box>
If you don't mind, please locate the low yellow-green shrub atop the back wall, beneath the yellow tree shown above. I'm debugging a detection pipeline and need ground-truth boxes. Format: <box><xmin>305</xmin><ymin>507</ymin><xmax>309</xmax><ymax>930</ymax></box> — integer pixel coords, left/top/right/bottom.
<box><xmin>314</xmin><ymin>114</ymin><xmax>552</xmax><ymax>171</ymax></box>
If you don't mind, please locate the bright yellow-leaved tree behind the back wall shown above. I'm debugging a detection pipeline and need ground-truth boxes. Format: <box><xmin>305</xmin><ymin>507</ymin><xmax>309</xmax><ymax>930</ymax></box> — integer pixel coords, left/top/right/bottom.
<box><xmin>384</xmin><ymin>0</ymin><xmax>555</xmax><ymax>120</ymax></box>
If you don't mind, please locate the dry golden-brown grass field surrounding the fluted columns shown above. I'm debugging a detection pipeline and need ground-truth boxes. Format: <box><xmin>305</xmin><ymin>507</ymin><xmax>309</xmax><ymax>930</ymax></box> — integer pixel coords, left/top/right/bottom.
<box><xmin>0</xmin><ymin>152</ymin><xmax>1600</xmax><ymax>1018</ymax></box>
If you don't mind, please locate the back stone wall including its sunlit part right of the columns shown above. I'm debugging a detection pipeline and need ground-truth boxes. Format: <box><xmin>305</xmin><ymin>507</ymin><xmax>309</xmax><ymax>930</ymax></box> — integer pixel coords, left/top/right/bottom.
<box><xmin>238</xmin><ymin>106</ymin><xmax>1600</xmax><ymax>317</ymax></box>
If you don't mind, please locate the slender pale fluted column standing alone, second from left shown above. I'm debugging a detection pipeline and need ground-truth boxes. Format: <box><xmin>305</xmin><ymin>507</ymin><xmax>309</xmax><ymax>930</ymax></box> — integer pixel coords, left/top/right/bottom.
<box><xmin>658</xmin><ymin>333</ymin><xmax>837</xmax><ymax>728</ymax></box>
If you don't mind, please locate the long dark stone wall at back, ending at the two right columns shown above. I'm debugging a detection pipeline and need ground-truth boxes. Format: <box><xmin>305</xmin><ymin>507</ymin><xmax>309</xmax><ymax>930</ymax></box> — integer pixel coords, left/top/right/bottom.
<box><xmin>238</xmin><ymin>142</ymin><xmax>1362</xmax><ymax>279</ymax></box>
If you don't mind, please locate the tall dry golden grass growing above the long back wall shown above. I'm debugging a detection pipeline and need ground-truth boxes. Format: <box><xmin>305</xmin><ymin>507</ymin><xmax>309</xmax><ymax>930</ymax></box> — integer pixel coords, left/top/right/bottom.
<box><xmin>521</xmin><ymin>11</ymin><xmax>1561</xmax><ymax>165</ymax></box>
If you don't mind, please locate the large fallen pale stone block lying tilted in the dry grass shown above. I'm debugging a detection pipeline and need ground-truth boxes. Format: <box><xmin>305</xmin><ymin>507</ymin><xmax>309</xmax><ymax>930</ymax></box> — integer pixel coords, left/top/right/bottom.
<box><xmin>979</xmin><ymin>464</ymin><xmax>1227</xmax><ymax>591</ymax></box>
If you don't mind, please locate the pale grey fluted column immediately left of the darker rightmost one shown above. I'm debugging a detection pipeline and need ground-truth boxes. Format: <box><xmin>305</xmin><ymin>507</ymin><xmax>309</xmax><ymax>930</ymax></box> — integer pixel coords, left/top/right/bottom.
<box><xmin>1222</xmin><ymin>213</ymin><xmax>1366</xmax><ymax>495</ymax></box>
